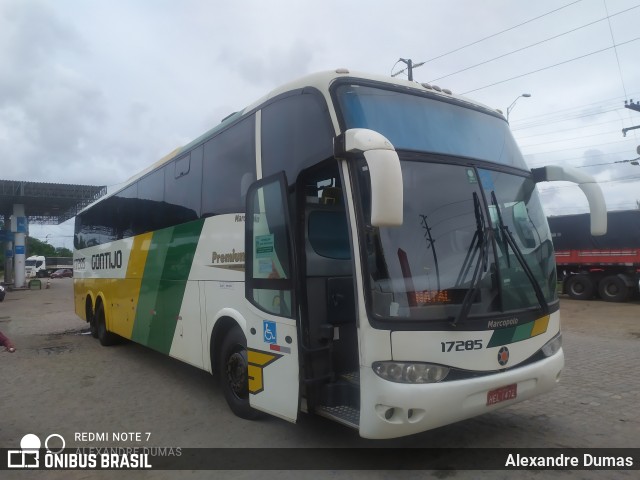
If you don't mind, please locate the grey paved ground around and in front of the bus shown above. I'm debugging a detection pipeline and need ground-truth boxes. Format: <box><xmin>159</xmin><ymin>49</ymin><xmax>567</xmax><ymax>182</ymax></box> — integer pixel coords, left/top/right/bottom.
<box><xmin>0</xmin><ymin>279</ymin><xmax>640</xmax><ymax>480</ymax></box>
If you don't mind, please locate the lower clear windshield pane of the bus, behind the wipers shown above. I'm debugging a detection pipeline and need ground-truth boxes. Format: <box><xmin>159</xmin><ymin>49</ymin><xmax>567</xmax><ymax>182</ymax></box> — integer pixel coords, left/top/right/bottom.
<box><xmin>357</xmin><ymin>155</ymin><xmax>556</xmax><ymax>321</ymax></box>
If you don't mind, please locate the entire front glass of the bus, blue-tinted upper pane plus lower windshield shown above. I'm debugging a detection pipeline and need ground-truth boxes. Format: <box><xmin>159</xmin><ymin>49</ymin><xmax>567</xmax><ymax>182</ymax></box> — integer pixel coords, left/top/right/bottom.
<box><xmin>335</xmin><ymin>84</ymin><xmax>557</xmax><ymax>323</ymax></box>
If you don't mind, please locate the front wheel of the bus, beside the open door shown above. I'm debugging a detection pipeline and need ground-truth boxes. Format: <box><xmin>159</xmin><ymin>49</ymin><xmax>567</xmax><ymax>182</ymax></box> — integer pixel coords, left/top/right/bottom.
<box><xmin>218</xmin><ymin>327</ymin><xmax>259</xmax><ymax>420</ymax></box>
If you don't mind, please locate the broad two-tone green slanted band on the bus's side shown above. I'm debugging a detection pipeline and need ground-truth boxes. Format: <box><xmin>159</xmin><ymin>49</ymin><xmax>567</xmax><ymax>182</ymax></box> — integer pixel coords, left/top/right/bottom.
<box><xmin>131</xmin><ymin>220</ymin><xmax>204</xmax><ymax>354</ymax></box>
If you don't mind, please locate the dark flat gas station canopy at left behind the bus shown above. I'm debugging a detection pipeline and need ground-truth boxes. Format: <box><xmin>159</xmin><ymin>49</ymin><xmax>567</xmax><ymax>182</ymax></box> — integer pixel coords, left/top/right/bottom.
<box><xmin>0</xmin><ymin>180</ymin><xmax>107</xmax><ymax>225</ymax></box>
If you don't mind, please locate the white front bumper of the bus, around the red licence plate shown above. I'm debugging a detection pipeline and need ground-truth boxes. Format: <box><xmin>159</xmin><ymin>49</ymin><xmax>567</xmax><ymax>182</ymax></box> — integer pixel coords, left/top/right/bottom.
<box><xmin>359</xmin><ymin>349</ymin><xmax>564</xmax><ymax>439</ymax></box>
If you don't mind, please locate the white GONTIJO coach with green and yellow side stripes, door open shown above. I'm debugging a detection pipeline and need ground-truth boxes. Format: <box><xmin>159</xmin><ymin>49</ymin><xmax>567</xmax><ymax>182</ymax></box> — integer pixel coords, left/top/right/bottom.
<box><xmin>74</xmin><ymin>69</ymin><xmax>606</xmax><ymax>438</ymax></box>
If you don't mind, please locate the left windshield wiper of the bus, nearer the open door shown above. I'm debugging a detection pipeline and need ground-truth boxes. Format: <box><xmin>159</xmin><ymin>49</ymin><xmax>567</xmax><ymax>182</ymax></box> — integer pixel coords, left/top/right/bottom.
<box><xmin>451</xmin><ymin>192</ymin><xmax>489</xmax><ymax>326</ymax></box>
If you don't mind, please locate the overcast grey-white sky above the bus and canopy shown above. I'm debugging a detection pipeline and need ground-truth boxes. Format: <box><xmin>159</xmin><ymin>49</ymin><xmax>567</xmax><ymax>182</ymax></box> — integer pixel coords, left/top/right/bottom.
<box><xmin>0</xmin><ymin>0</ymin><xmax>640</xmax><ymax>247</ymax></box>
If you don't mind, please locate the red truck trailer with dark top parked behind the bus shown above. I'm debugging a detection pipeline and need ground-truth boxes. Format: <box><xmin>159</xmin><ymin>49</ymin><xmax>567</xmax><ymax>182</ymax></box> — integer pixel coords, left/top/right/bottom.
<box><xmin>547</xmin><ymin>210</ymin><xmax>640</xmax><ymax>302</ymax></box>
